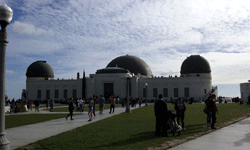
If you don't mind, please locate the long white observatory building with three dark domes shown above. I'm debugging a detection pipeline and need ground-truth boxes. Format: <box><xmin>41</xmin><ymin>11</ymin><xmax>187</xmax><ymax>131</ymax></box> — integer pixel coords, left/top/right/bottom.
<box><xmin>25</xmin><ymin>55</ymin><xmax>218</xmax><ymax>101</ymax></box>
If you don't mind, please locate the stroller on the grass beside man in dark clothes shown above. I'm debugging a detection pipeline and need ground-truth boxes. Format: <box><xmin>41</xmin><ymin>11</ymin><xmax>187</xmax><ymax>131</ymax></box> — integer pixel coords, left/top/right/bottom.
<box><xmin>167</xmin><ymin>110</ymin><xmax>182</xmax><ymax>136</ymax></box>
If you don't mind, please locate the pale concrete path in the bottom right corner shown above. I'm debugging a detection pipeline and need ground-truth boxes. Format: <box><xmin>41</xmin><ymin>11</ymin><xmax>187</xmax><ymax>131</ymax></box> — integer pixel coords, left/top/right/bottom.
<box><xmin>169</xmin><ymin>118</ymin><xmax>250</xmax><ymax>150</ymax></box>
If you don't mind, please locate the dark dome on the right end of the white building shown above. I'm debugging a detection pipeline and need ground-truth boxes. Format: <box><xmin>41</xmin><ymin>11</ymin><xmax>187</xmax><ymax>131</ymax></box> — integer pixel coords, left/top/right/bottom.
<box><xmin>181</xmin><ymin>55</ymin><xmax>211</xmax><ymax>74</ymax></box>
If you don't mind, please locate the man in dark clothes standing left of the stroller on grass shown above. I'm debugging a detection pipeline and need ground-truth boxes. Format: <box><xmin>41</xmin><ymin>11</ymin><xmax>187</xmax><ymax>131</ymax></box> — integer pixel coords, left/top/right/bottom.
<box><xmin>154</xmin><ymin>94</ymin><xmax>168</xmax><ymax>137</ymax></box>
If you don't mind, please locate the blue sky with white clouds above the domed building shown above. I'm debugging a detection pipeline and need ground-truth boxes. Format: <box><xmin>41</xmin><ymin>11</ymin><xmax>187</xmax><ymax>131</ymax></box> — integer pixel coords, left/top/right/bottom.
<box><xmin>4</xmin><ymin>0</ymin><xmax>250</xmax><ymax>98</ymax></box>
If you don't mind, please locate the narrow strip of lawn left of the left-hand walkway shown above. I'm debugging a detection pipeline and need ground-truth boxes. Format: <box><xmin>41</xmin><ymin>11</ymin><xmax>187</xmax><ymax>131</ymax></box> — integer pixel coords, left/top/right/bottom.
<box><xmin>5</xmin><ymin>114</ymin><xmax>68</xmax><ymax>129</ymax></box>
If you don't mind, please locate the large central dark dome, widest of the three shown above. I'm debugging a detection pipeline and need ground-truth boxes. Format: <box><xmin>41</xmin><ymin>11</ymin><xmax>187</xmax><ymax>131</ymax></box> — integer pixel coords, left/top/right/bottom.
<box><xmin>106</xmin><ymin>55</ymin><xmax>152</xmax><ymax>76</ymax></box>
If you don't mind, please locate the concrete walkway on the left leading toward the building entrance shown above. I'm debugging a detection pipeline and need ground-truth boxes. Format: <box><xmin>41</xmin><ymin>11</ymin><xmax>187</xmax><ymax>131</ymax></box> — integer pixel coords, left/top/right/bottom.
<box><xmin>5</xmin><ymin>104</ymin><xmax>144</xmax><ymax>150</ymax></box>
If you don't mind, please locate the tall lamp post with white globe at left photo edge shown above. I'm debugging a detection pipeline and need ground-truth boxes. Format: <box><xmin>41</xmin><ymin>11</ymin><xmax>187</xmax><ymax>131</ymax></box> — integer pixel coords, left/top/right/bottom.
<box><xmin>0</xmin><ymin>3</ymin><xmax>13</xmax><ymax>150</ymax></box>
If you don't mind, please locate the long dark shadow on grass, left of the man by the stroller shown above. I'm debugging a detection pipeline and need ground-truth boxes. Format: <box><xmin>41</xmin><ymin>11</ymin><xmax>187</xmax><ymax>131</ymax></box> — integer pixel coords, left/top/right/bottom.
<box><xmin>89</xmin><ymin>131</ymin><xmax>156</xmax><ymax>149</ymax></box>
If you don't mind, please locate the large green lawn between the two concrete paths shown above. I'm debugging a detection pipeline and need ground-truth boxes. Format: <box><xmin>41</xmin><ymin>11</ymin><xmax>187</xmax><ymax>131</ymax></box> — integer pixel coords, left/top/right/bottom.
<box><xmin>15</xmin><ymin>103</ymin><xmax>250</xmax><ymax>150</ymax></box>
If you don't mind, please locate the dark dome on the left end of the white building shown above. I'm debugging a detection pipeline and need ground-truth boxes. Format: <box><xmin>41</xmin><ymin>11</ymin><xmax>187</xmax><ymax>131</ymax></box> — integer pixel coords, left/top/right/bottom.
<box><xmin>26</xmin><ymin>61</ymin><xmax>54</xmax><ymax>78</ymax></box>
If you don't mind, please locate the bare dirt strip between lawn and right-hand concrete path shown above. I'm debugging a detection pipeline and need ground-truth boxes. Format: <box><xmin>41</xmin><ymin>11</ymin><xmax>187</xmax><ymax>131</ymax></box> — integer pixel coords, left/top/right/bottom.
<box><xmin>148</xmin><ymin>116</ymin><xmax>248</xmax><ymax>150</ymax></box>
